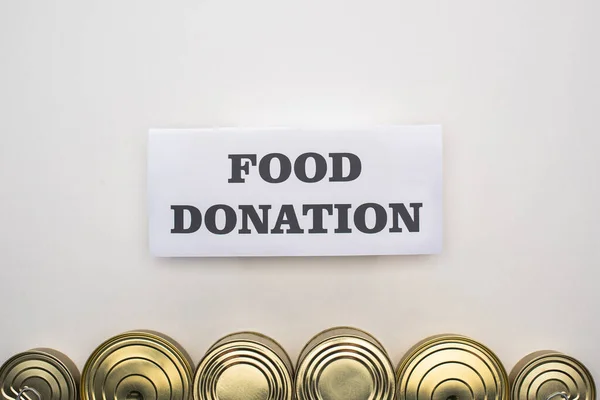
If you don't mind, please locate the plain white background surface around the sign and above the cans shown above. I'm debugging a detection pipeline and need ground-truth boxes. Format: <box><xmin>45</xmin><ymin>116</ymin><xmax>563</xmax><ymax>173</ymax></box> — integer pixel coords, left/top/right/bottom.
<box><xmin>0</xmin><ymin>0</ymin><xmax>600</xmax><ymax>379</ymax></box>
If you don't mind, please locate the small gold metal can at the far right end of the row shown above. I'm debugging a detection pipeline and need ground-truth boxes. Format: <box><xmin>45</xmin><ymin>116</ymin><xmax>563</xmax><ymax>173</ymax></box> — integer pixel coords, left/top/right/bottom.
<box><xmin>510</xmin><ymin>350</ymin><xmax>596</xmax><ymax>400</ymax></box>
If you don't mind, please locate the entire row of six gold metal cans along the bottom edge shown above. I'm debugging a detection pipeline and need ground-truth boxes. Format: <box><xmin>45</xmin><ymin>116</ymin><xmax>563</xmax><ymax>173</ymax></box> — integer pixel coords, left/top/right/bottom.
<box><xmin>0</xmin><ymin>327</ymin><xmax>596</xmax><ymax>400</ymax></box>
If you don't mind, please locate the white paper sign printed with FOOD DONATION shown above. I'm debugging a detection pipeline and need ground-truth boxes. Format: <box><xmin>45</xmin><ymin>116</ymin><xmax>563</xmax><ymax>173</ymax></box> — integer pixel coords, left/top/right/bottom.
<box><xmin>147</xmin><ymin>125</ymin><xmax>442</xmax><ymax>257</ymax></box>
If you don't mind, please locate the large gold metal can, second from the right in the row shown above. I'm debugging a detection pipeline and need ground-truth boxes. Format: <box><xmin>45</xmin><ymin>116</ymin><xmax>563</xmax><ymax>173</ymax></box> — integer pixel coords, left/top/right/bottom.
<box><xmin>397</xmin><ymin>335</ymin><xmax>508</xmax><ymax>400</ymax></box>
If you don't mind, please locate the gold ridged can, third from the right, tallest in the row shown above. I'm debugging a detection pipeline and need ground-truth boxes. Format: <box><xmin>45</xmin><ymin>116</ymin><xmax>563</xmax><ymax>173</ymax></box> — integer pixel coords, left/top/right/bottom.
<box><xmin>296</xmin><ymin>327</ymin><xmax>396</xmax><ymax>400</ymax></box>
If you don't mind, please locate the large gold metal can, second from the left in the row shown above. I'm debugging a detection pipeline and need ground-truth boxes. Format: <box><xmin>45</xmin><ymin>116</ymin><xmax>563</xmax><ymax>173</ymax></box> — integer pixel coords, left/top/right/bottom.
<box><xmin>81</xmin><ymin>331</ymin><xmax>192</xmax><ymax>400</ymax></box>
